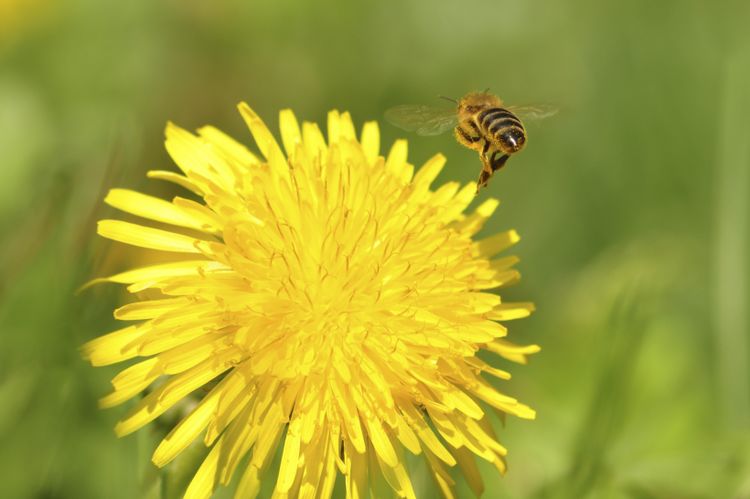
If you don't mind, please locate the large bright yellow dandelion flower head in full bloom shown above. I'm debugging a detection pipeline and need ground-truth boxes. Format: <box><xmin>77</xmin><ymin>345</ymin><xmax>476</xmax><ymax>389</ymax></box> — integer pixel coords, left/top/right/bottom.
<box><xmin>83</xmin><ymin>104</ymin><xmax>539</xmax><ymax>498</ymax></box>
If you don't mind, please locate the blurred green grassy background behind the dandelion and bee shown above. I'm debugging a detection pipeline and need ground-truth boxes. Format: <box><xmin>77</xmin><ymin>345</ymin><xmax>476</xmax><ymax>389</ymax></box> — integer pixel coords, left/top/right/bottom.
<box><xmin>0</xmin><ymin>0</ymin><xmax>750</xmax><ymax>499</ymax></box>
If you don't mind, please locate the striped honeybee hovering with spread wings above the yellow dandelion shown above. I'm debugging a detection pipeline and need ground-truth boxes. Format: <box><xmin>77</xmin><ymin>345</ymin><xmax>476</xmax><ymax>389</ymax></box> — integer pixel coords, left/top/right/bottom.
<box><xmin>385</xmin><ymin>90</ymin><xmax>556</xmax><ymax>193</ymax></box>
